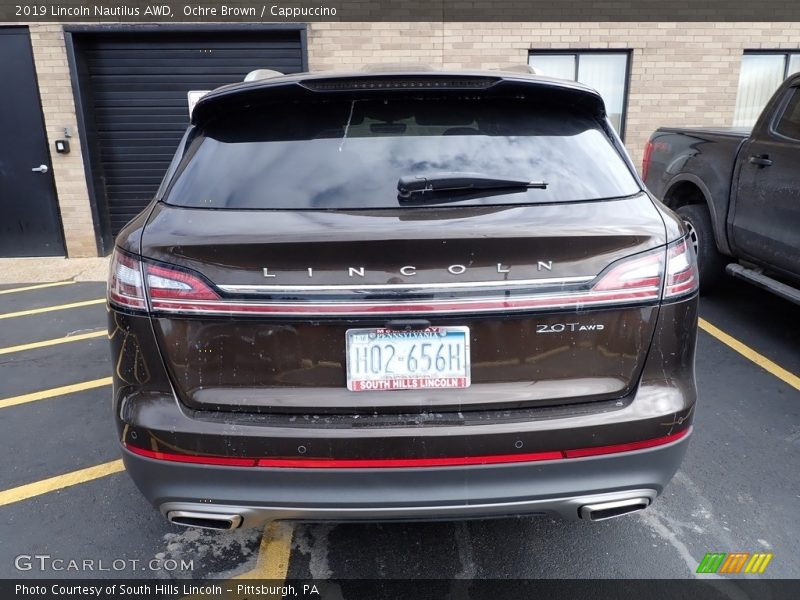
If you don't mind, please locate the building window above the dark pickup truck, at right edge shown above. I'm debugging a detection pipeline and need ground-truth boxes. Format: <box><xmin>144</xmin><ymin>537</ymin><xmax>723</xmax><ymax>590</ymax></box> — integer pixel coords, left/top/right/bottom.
<box><xmin>733</xmin><ymin>52</ymin><xmax>800</xmax><ymax>127</ymax></box>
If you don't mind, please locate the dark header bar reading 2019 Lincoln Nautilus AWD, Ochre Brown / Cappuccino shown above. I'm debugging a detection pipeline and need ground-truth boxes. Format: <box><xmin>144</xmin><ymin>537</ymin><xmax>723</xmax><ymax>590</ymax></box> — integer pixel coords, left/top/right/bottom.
<box><xmin>0</xmin><ymin>0</ymin><xmax>800</xmax><ymax>24</ymax></box>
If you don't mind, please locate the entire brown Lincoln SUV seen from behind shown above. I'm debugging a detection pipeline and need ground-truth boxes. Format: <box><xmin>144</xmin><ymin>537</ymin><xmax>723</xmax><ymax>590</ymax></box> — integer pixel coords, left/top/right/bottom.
<box><xmin>108</xmin><ymin>71</ymin><xmax>697</xmax><ymax>529</ymax></box>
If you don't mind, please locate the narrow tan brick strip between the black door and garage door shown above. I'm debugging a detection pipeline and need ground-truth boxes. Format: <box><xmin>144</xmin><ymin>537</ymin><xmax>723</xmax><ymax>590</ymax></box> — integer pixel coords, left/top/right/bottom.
<box><xmin>29</xmin><ymin>25</ymin><xmax>97</xmax><ymax>258</ymax></box>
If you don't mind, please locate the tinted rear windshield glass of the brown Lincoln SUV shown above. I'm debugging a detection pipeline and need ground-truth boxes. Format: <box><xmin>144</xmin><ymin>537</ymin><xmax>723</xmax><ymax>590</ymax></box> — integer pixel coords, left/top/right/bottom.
<box><xmin>166</xmin><ymin>96</ymin><xmax>639</xmax><ymax>210</ymax></box>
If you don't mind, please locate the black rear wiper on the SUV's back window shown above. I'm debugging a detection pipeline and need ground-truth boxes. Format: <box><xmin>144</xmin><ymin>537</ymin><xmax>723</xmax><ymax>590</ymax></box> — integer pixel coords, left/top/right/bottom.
<box><xmin>397</xmin><ymin>172</ymin><xmax>547</xmax><ymax>200</ymax></box>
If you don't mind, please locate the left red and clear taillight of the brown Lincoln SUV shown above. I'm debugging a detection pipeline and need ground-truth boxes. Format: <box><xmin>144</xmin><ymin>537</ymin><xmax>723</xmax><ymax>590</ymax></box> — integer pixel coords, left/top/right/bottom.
<box><xmin>108</xmin><ymin>250</ymin><xmax>220</xmax><ymax>309</ymax></box>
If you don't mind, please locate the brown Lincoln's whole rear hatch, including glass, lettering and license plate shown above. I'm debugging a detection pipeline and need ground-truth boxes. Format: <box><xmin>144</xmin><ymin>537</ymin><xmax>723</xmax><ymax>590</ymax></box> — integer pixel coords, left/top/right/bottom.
<box><xmin>125</xmin><ymin>75</ymin><xmax>680</xmax><ymax>418</ymax></box>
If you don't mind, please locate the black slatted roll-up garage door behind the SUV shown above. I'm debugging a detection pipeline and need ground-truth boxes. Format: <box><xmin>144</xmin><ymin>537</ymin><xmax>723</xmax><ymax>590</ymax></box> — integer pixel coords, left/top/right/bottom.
<box><xmin>72</xmin><ymin>30</ymin><xmax>305</xmax><ymax>249</ymax></box>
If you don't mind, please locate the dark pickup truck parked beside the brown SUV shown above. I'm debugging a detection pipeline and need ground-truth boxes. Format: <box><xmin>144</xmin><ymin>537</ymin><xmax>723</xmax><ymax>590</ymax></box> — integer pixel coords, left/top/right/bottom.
<box><xmin>642</xmin><ymin>73</ymin><xmax>800</xmax><ymax>303</ymax></box>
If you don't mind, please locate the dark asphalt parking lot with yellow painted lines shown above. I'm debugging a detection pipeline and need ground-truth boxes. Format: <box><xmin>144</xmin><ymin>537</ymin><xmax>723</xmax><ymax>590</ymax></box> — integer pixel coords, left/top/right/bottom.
<box><xmin>0</xmin><ymin>281</ymin><xmax>800</xmax><ymax>584</ymax></box>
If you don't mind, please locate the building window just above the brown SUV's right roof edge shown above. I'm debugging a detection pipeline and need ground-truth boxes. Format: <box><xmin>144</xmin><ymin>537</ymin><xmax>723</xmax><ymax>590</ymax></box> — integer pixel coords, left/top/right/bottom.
<box><xmin>528</xmin><ymin>50</ymin><xmax>630</xmax><ymax>135</ymax></box>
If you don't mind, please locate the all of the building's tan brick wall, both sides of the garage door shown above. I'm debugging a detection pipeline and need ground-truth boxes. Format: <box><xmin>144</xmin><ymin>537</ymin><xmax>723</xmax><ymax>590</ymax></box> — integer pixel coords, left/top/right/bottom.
<box><xmin>4</xmin><ymin>22</ymin><xmax>800</xmax><ymax>257</ymax></box>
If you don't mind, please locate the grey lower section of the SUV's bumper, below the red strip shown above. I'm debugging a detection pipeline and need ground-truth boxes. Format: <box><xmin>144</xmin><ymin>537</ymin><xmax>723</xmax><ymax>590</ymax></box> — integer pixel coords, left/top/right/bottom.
<box><xmin>123</xmin><ymin>428</ymin><xmax>689</xmax><ymax>527</ymax></box>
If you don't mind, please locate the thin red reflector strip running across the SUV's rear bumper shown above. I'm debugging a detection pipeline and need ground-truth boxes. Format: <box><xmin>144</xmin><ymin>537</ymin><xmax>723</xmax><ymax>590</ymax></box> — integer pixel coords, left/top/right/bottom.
<box><xmin>125</xmin><ymin>427</ymin><xmax>692</xmax><ymax>469</ymax></box>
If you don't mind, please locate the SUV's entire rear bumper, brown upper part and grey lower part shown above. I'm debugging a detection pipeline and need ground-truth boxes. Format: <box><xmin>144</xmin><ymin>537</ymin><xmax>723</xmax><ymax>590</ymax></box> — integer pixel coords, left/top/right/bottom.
<box><xmin>112</xmin><ymin>297</ymin><xmax>697</xmax><ymax>527</ymax></box>
